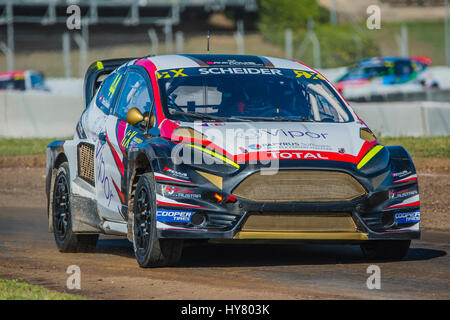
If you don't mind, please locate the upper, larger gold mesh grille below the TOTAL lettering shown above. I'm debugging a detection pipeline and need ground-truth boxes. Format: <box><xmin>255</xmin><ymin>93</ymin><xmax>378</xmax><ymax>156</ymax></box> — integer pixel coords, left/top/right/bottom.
<box><xmin>232</xmin><ymin>170</ymin><xmax>366</xmax><ymax>202</ymax></box>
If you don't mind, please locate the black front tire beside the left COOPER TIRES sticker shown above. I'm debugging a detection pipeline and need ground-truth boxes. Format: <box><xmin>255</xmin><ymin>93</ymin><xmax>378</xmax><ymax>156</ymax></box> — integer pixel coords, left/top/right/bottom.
<box><xmin>132</xmin><ymin>173</ymin><xmax>183</xmax><ymax>268</ymax></box>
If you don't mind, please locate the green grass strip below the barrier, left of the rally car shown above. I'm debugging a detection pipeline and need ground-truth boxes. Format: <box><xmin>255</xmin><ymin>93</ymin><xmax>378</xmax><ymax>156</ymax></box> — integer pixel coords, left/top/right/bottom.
<box><xmin>0</xmin><ymin>138</ymin><xmax>61</xmax><ymax>156</ymax></box>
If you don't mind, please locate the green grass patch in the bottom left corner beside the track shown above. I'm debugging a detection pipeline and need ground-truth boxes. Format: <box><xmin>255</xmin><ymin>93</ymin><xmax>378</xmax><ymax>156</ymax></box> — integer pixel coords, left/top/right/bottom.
<box><xmin>0</xmin><ymin>279</ymin><xmax>86</xmax><ymax>300</ymax></box>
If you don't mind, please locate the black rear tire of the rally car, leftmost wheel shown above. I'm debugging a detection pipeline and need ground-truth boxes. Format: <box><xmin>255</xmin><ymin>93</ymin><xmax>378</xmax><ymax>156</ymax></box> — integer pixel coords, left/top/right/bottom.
<box><xmin>51</xmin><ymin>162</ymin><xmax>98</xmax><ymax>252</ymax></box>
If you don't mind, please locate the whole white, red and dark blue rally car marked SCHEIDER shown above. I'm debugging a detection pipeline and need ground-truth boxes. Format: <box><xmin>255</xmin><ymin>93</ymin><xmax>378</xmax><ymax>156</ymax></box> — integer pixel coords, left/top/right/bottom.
<box><xmin>46</xmin><ymin>55</ymin><xmax>420</xmax><ymax>267</ymax></box>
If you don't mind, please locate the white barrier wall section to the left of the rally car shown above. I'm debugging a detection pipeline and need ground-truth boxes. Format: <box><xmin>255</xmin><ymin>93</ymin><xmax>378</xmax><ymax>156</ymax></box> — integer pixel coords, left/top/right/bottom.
<box><xmin>0</xmin><ymin>91</ymin><xmax>83</xmax><ymax>138</ymax></box>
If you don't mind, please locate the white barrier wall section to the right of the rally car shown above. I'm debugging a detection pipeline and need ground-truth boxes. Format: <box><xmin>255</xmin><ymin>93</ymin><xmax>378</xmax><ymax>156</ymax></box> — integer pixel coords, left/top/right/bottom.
<box><xmin>350</xmin><ymin>101</ymin><xmax>450</xmax><ymax>137</ymax></box>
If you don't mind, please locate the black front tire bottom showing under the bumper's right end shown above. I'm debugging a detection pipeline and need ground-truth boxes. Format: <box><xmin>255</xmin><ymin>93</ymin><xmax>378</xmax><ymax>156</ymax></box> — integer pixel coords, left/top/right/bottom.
<box><xmin>361</xmin><ymin>240</ymin><xmax>411</xmax><ymax>260</ymax></box>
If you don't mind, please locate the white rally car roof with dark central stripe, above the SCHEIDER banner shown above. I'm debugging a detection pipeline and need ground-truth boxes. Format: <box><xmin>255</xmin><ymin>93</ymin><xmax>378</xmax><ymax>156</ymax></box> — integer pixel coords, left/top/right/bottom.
<box><xmin>147</xmin><ymin>54</ymin><xmax>317</xmax><ymax>72</ymax></box>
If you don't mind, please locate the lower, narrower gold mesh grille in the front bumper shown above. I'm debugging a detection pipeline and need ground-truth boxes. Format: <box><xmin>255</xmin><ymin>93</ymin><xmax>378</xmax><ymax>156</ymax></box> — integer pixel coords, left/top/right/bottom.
<box><xmin>241</xmin><ymin>212</ymin><xmax>357</xmax><ymax>232</ymax></box>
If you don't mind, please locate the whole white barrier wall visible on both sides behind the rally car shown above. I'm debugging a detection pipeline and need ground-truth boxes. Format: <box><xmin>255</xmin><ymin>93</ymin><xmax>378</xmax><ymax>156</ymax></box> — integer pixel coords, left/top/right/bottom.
<box><xmin>0</xmin><ymin>91</ymin><xmax>450</xmax><ymax>138</ymax></box>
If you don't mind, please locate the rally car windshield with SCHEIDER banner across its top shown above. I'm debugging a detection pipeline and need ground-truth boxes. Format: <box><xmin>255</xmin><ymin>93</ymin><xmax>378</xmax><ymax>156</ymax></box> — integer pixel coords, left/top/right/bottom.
<box><xmin>157</xmin><ymin>68</ymin><xmax>353</xmax><ymax>122</ymax></box>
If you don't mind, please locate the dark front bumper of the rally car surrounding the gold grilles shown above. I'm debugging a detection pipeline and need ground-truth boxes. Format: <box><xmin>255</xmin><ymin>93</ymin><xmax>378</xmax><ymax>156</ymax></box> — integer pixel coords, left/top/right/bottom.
<box><xmin>153</xmin><ymin>160</ymin><xmax>420</xmax><ymax>241</ymax></box>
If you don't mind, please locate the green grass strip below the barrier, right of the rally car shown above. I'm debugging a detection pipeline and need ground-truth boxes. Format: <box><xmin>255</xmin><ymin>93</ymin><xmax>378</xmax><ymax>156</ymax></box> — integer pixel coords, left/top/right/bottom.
<box><xmin>379</xmin><ymin>137</ymin><xmax>450</xmax><ymax>158</ymax></box>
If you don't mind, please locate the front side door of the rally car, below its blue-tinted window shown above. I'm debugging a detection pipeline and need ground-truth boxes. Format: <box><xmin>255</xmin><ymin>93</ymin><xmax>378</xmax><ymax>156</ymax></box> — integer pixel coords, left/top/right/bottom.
<box><xmin>98</xmin><ymin>67</ymin><xmax>153</xmax><ymax>220</ymax></box>
